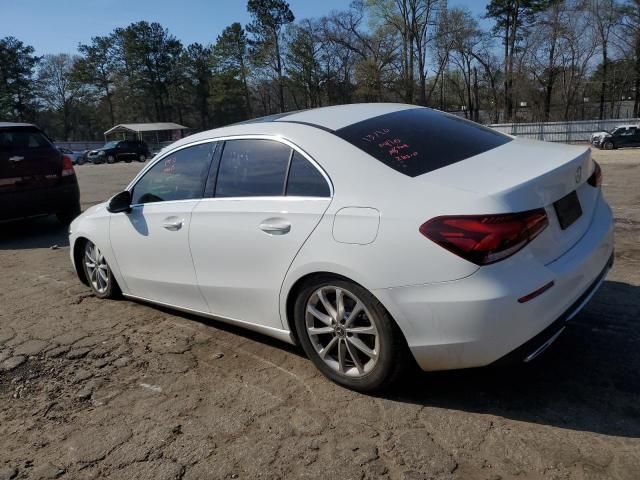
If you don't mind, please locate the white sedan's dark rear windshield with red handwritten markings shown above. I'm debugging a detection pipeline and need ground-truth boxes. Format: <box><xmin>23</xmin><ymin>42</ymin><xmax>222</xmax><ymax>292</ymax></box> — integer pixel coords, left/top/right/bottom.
<box><xmin>335</xmin><ymin>108</ymin><xmax>511</xmax><ymax>177</ymax></box>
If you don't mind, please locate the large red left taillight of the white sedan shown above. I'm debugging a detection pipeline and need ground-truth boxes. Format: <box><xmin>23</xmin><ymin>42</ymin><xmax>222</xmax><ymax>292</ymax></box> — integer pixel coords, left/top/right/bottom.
<box><xmin>420</xmin><ymin>208</ymin><xmax>549</xmax><ymax>265</ymax></box>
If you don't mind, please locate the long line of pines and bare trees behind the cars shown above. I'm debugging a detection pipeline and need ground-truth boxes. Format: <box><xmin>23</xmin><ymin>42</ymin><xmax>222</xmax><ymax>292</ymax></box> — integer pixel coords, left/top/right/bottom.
<box><xmin>0</xmin><ymin>0</ymin><xmax>640</xmax><ymax>140</ymax></box>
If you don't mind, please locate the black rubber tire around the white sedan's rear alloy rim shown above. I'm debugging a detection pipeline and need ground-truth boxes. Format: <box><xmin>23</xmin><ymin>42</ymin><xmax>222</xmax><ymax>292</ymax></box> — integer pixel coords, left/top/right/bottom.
<box><xmin>294</xmin><ymin>276</ymin><xmax>410</xmax><ymax>392</ymax></box>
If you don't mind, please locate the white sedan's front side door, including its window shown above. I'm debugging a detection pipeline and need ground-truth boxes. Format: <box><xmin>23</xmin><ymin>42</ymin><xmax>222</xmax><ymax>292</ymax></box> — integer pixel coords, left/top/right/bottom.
<box><xmin>110</xmin><ymin>143</ymin><xmax>215</xmax><ymax>312</ymax></box>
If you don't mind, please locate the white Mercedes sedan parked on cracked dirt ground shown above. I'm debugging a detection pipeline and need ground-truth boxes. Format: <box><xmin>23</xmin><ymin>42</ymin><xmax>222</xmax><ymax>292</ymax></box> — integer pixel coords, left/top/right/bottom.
<box><xmin>70</xmin><ymin>104</ymin><xmax>613</xmax><ymax>391</ymax></box>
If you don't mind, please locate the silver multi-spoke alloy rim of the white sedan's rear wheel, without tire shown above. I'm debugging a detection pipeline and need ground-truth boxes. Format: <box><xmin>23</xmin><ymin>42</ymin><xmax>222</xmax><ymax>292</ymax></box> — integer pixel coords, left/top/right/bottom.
<box><xmin>305</xmin><ymin>285</ymin><xmax>380</xmax><ymax>377</ymax></box>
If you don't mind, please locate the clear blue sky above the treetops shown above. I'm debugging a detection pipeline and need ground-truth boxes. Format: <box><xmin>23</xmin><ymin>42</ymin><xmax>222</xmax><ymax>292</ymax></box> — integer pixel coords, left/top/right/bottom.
<box><xmin>0</xmin><ymin>0</ymin><xmax>487</xmax><ymax>55</ymax></box>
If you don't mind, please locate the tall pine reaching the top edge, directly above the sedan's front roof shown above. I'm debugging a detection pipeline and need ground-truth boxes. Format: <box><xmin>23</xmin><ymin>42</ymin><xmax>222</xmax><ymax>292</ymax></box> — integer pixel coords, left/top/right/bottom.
<box><xmin>247</xmin><ymin>0</ymin><xmax>295</xmax><ymax>112</ymax></box>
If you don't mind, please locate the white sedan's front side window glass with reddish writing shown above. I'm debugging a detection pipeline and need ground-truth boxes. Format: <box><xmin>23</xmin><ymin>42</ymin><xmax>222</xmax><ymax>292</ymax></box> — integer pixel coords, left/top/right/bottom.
<box><xmin>131</xmin><ymin>143</ymin><xmax>216</xmax><ymax>204</ymax></box>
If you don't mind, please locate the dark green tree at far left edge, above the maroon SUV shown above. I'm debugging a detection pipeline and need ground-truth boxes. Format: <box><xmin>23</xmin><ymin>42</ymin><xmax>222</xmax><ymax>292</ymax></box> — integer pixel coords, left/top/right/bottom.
<box><xmin>0</xmin><ymin>37</ymin><xmax>40</xmax><ymax>121</ymax></box>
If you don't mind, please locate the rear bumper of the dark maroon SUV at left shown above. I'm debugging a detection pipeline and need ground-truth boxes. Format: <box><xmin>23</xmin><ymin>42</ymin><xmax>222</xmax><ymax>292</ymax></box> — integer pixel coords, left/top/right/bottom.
<box><xmin>0</xmin><ymin>181</ymin><xmax>80</xmax><ymax>220</ymax></box>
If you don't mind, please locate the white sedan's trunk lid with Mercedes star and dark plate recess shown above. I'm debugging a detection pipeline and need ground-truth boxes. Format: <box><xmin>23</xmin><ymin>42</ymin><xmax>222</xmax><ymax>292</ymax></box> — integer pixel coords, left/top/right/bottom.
<box><xmin>423</xmin><ymin>139</ymin><xmax>599</xmax><ymax>264</ymax></box>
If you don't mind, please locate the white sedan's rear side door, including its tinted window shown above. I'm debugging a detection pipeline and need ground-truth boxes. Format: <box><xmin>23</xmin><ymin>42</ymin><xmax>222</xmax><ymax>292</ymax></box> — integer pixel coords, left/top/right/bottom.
<box><xmin>190</xmin><ymin>139</ymin><xmax>331</xmax><ymax>329</ymax></box>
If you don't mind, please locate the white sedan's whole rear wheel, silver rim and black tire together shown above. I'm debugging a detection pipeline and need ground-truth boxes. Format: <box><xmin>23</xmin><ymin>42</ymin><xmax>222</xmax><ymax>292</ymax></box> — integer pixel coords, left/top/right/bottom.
<box><xmin>295</xmin><ymin>279</ymin><xmax>406</xmax><ymax>392</ymax></box>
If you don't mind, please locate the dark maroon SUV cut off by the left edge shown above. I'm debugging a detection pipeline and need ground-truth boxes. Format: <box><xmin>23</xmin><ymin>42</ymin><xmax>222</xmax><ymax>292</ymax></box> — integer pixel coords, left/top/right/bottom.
<box><xmin>0</xmin><ymin>122</ymin><xmax>80</xmax><ymax>224</ymax></box>
